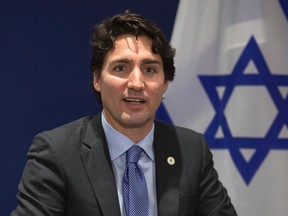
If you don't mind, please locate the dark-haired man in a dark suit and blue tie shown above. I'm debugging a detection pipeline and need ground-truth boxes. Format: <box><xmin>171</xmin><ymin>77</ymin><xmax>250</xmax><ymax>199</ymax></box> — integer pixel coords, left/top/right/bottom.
<box><xmin>11</xmin><ymin>13</ymin><xmax>236</xmax><ymax>216</ymax></box>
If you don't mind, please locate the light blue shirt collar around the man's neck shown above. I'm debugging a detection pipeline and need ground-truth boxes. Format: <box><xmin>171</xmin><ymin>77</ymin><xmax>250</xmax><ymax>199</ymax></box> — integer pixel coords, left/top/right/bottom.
<box><xmin>101</xmin><ymin>111</ymin><xmax>154</xmax><ymax>161</ymax></box>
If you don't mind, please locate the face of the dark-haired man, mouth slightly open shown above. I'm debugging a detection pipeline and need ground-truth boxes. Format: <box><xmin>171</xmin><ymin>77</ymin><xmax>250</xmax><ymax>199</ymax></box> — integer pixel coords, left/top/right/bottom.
<box><xmin>93</xmin><ymin>34</ymin><xmax>168</xmax><ymax>138</ymax></box>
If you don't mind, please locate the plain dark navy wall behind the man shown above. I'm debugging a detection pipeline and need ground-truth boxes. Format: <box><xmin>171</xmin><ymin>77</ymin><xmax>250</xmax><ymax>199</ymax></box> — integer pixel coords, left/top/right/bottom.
<box><xmin>0</xmin><ymin>0</ymin><xmax>178</xmax><ymax>216</ymax></box>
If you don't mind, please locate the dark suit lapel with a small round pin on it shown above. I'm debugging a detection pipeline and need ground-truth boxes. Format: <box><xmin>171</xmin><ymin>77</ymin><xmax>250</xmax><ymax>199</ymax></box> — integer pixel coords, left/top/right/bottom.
<box><xmin>154</xmin><ymin>121</ymin><xmax>181</xmax><ymax>216</ymax></box>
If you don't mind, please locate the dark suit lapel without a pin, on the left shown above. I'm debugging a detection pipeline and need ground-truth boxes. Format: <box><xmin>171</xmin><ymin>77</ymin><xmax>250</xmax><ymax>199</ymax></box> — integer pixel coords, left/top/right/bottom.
<box><xmin>81</xmin><ymin>115</ymin><xmax>120</xmax><ymax>216</ymax></box>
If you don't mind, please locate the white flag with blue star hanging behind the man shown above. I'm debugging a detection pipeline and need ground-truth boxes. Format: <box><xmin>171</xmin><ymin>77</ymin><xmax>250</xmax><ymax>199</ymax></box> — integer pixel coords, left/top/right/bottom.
<box><xmin>164</xmin><ymin>0</ymin><xmax>288</xmax><ymax>216</ymax></box>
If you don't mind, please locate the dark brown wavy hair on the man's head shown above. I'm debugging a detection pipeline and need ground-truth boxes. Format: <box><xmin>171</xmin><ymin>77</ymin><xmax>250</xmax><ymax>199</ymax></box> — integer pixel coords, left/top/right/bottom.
<box><xmin>90</xmin><ymin>12</ymin><xmax>175</xmax><ymax>103</ymax></box>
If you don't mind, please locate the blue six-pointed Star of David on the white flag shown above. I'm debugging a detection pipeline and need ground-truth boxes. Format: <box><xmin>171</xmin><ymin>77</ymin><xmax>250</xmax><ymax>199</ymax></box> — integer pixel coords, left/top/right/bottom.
<box><xmin>199</xmin><ymin>36</ymin><xmax>288</xmax><ymax>185</ymax></box>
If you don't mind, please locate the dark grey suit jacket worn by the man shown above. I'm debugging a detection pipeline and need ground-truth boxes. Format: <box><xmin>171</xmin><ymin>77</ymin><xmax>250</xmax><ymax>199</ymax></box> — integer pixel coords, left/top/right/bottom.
<box><xmin>11</xmin><ymin>115</ymin><xmax>236</xmax><ymax>216</ymax></box>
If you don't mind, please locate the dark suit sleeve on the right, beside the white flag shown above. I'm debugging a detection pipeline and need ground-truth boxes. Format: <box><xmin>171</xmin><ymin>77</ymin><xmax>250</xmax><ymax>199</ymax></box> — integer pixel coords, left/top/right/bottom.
<box><xmin>197</xmin><ymin>136</ymin><xmax>237</xmax><ymax>216</ymax></box>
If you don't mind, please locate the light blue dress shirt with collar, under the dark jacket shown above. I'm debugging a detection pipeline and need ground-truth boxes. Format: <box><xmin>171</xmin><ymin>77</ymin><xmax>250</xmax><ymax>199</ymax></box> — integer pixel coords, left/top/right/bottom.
<box><xmin>102</xmin><ymin>112</ymin><xmax>158</xmax><ymax>216</ymax></box>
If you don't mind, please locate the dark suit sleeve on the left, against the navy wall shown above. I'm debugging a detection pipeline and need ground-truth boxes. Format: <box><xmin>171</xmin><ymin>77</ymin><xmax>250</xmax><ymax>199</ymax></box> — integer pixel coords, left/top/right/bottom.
<box><xmin>11</xmin><ymin>134</ymin><xmax>65</xmax><ymax>216</ymax></box>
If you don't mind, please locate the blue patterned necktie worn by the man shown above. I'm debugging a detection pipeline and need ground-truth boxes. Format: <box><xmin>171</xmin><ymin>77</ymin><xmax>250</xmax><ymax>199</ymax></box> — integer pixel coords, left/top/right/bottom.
<box><xmin>123</xmin><ymin>145</ymin><xmax>149</xmax><ymax>216</ymax></box>
